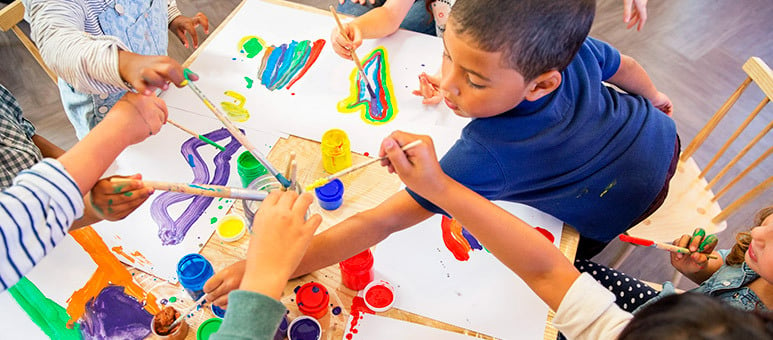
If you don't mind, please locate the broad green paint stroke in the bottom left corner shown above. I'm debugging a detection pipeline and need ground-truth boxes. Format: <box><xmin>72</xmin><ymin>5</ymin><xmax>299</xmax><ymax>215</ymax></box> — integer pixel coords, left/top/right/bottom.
<box><xmin>8</xmin><ymin>277</ymin><xmax>83</xmax><ymax>339</ymax></box>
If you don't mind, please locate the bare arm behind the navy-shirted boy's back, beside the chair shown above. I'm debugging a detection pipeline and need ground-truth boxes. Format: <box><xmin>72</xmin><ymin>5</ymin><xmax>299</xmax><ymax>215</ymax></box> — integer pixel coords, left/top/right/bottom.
<box><xmin>607</xmin><ymin>54</ymin><xmax>673</xmax><ymax>116</ymax></box>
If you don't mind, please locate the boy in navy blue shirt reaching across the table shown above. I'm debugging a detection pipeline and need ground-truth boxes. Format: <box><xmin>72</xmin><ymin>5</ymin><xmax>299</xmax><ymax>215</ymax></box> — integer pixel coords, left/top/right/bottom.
<box><xmin>204</xmin><ymin>0</ymin><xmax>678</xmax><ymax>303</ymax></box>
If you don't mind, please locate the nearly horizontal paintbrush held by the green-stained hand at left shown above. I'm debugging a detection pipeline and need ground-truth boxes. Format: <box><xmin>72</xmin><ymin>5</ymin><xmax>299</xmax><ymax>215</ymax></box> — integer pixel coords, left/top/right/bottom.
<box><xmin>110</xmin><ymin>178</ymin><xmax>268</xmax><ymax>201</ymax></box>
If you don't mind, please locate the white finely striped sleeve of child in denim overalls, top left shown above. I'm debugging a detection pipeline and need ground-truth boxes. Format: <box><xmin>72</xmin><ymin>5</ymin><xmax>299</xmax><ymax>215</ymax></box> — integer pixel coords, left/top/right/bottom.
<box><xmin>24</xmin><ymin>0</ymin><xmax>130</xmax><ymax>94</ymax></box>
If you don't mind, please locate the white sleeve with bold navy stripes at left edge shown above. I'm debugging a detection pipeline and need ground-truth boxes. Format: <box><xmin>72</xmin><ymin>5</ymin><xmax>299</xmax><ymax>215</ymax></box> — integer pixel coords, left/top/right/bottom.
<box><xmin>0</xmin><ymin>159</ymin><xmax>84</xmax><ymax>291</ymax></box>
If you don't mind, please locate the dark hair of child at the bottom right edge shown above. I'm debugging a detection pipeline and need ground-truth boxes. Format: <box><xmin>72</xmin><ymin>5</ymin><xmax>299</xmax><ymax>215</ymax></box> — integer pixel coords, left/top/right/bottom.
<box><xmin>618</xmin><ymin>293</ymin><xmax>773</xmax><ymax>340</ymax></box>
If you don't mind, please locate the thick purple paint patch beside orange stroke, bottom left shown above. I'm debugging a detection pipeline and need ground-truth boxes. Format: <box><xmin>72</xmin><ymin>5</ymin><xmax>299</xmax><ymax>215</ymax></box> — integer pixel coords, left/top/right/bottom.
<box><xmin>80</xmin><ymin>285</ymin><xmax>153</xmax><ymax>339</ymax></box>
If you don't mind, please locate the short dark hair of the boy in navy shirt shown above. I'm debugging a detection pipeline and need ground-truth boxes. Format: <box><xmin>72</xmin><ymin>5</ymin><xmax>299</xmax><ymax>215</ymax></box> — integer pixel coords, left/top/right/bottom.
<box><xmin>448</xmin><ymin>0</ymin><xmax>596</xmax><ymax>81</ymax></box>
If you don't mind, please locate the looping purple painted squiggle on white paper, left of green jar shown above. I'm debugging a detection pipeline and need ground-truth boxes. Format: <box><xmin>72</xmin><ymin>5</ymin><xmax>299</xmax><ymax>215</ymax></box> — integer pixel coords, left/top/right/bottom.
<box><xmin>150</xmin><ymin>129</ymin><xmax>238</xmax><ymax>245</ymax></box>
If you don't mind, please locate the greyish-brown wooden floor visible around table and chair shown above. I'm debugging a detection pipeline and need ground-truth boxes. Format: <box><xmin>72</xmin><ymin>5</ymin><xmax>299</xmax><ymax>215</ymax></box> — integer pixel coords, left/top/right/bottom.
<box><xmin>0</xmin><ymin>0</ymin><xmax>773</xmax><ymax>288</ymax></box>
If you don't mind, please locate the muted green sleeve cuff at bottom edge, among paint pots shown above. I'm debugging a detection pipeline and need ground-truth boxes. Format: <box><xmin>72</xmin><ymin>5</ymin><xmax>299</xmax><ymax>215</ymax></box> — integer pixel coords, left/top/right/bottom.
<box><xmin>210</xmin><ymin>290</ymin><xmax>287</xmax><ymax>340</ymax></box>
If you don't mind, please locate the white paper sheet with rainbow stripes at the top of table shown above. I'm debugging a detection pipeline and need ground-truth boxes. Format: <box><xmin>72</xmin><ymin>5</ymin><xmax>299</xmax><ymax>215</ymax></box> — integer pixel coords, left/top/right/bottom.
<box><xmin>163</xmin><ymin>1</ymin><xmax>468</xmax><ymax>154</ymax></box>
